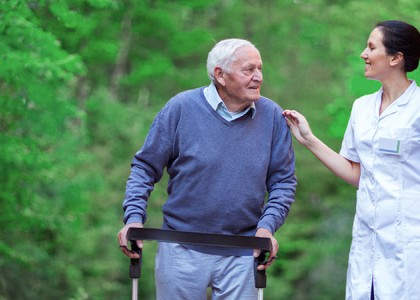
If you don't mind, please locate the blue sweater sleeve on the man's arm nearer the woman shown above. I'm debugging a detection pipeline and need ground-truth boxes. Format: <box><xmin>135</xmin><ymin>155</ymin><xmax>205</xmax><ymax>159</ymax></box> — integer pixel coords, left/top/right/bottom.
<box><xmin>258</xmin><ymin>108</ymin><xmax>297</xmax><ymax>234</ymax></box>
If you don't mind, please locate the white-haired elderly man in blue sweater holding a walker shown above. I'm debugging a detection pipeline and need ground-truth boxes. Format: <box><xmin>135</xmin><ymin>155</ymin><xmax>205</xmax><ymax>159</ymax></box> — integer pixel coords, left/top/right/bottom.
<box><xmin>118</xmin><ymin>39</ymin><xmax>296</xmax><ymax>299</ymax></box>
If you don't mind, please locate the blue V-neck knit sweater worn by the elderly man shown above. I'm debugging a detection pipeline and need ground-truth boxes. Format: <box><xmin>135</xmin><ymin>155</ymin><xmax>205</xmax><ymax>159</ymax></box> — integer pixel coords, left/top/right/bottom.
<box><xmin>123</xmin><ymin>88</ymin><xmax>296</xmax><ymax>255</ymax></box>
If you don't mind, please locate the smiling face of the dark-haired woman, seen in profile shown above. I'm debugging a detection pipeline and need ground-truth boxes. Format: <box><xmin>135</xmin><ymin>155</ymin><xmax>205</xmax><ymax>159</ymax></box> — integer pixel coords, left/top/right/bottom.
<box><xmin>360</xmin><ymin>28</ymin><xmax>392</xmax><ymax>81</ymax></box>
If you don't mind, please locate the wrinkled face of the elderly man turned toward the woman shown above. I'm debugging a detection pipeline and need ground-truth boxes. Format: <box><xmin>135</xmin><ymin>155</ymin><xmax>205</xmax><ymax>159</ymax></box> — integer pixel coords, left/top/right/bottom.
<box><xmin>219</xmin><ymin>46</ymin><xmax>263</xmax><ymax>111</ymax></box>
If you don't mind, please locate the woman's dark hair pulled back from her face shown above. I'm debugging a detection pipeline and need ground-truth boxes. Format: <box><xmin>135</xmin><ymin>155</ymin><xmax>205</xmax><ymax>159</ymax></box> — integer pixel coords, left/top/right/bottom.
<box><xmin>375</xmin><ymin>20</ymin><xmax>420</xmax><ymax>72</ymax></box>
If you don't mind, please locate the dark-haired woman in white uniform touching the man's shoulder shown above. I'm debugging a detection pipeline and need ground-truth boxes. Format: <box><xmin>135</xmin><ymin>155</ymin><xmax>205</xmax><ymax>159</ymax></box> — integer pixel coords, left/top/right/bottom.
<box><xmin>284</xmin><ymin>21</ymin><xmax>420</xmax><ymax>300</ymax></box>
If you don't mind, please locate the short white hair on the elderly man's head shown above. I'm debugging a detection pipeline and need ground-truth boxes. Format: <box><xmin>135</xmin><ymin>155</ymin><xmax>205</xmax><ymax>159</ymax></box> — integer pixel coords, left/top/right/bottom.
<box><xmin>207</xmin><ymin>39</ymin><xmax>258</xmax><ymax>81</ymax></box>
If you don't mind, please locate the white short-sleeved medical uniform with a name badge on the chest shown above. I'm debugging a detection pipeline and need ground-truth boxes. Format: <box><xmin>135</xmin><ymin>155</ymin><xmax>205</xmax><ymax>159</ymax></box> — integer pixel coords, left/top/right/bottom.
<box><xmin>340</xmin><ymin>81</ymin><xmax>420</xmax><ymax>300</ymax></box>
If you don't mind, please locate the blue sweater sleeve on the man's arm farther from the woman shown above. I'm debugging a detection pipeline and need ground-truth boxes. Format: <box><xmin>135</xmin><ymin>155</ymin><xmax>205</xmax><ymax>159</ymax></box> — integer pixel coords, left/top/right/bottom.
<box><xmin>123</xmin><ymin>104</ymin><xmax>176</xmax><ymax>224</ymax></box>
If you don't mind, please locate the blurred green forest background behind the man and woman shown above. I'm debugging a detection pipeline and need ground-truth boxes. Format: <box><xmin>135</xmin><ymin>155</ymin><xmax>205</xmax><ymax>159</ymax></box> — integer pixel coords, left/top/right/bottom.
<box><xmin>0</xmin><ymin>0</ymin><xmax>420</xmax><ymax>300</ymax></box>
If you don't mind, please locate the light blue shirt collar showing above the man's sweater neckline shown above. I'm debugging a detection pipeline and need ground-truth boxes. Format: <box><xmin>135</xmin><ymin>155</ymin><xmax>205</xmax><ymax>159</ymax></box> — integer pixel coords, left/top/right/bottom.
<box><xmin>204</xmin><ymin>82</ymin><xmax>256</xmax><ymax>121</ymax></box>
